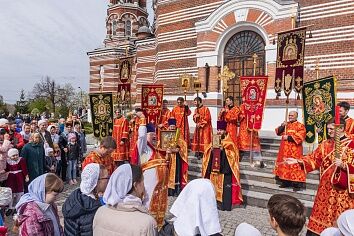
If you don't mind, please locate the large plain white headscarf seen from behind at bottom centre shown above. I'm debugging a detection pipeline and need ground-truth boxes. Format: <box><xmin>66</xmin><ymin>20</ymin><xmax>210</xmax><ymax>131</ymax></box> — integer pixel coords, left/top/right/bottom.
<box><xmin>170</xmin><ymin>179</ymin><xmax>221</xmax><ymax>236</ymax></box>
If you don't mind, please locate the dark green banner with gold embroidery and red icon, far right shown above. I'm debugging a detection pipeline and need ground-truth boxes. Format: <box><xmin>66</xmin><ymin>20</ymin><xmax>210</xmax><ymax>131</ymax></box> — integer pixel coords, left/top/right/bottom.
<box><xmin>302</xmin><ymin>76</ymin><xmax>337</xmax><ymax>143</ymax></box>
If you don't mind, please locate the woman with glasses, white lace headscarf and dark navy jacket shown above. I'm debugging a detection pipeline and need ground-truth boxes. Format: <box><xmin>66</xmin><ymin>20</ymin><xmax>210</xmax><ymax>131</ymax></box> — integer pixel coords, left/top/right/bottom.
<box><xmin>63</xmin><ymin>163</ymin><xmax>109</xmax><ymax>236</ymax></box>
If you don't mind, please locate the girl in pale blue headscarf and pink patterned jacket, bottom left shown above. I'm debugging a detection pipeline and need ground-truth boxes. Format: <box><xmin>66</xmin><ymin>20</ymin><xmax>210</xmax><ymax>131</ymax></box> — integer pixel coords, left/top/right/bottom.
<box><xmin>16</xmin><ymin>173</ymin><xmax>64</xmax><ymax>236</ymax></box>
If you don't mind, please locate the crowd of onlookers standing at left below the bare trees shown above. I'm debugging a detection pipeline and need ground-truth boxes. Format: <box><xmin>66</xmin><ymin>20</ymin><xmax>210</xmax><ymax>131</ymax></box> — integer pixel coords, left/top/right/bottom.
<box><xmin>0</xmin><ymin>113</ymin><xmax>86</xmax><ymax>224</ymax></box>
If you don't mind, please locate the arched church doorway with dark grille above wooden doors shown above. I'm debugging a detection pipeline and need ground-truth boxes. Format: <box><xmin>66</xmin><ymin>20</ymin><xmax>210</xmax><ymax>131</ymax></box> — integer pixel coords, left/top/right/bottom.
<box><xmin>224</xmin><ymin>30</ymin><xmax>265</xmax><ymax>105</ymax></box>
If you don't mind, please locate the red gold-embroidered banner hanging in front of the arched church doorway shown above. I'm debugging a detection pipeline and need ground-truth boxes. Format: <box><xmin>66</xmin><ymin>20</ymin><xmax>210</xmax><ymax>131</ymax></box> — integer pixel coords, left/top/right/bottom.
<box><xmin>240</xmin><ymin>76</ymin><xmax>268</xmax><ymax>130</ymax></box>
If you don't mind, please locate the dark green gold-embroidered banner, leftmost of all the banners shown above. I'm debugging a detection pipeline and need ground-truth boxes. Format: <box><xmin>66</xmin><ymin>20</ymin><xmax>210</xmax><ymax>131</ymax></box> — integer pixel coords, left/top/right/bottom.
<box><xmin>90</xmin><ymin>93</ymin><xmax>113</xmax><ymax>138</ymax></box>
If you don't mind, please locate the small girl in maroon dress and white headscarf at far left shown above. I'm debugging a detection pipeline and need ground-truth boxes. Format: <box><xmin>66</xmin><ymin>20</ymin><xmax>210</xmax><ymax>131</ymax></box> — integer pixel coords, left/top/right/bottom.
<box><xmin>5</xmin><ymin>148</ymin><xmax>29</xmax><ymax>216</ymax></box>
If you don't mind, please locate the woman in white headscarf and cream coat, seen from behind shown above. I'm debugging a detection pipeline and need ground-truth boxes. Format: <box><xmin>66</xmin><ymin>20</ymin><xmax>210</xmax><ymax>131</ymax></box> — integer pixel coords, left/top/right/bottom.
<box><xmin>93</xmin><ymin>164</ymin><xmax>157</xmax><ymax>236</ymax></box>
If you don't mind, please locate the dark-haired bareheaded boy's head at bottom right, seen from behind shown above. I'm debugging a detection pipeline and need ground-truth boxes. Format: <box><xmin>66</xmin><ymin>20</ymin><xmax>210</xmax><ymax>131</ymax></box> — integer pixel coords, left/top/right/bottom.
<box><xmin>267</xmin><ymin>194</ymin><xmax>306</xmax><ymax>236</ymax></box>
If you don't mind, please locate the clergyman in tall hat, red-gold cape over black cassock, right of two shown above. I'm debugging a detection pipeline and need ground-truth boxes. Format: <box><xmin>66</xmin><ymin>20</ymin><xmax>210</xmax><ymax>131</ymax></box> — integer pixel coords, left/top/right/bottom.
<box><xmin>202</xmin><ymin>121</ymin><xmax>243</xmax><ymax>211</ymax></box>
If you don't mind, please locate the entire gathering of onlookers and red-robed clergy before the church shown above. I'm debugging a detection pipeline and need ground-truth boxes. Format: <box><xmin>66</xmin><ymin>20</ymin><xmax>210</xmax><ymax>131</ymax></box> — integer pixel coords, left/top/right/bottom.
<box><xmin>0</xmin><ymin>97</ymin><xmax>354</xmax><ymax>236</ymax></box>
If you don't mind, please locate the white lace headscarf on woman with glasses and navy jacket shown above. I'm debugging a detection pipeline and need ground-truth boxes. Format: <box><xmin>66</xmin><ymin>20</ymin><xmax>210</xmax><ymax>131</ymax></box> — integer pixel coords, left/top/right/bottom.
<box><xmin>80</xmin><ymin>163</ymin><xmax>100</xmax><ymax>196</ymax></box>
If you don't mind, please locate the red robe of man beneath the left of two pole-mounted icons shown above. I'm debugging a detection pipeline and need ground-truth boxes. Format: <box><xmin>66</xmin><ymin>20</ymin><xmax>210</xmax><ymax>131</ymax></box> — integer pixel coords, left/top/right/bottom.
<box><xmin>171</xmin><ymin>106</ymin><xmax>192</xmax><ymax>146</ymax></box>
